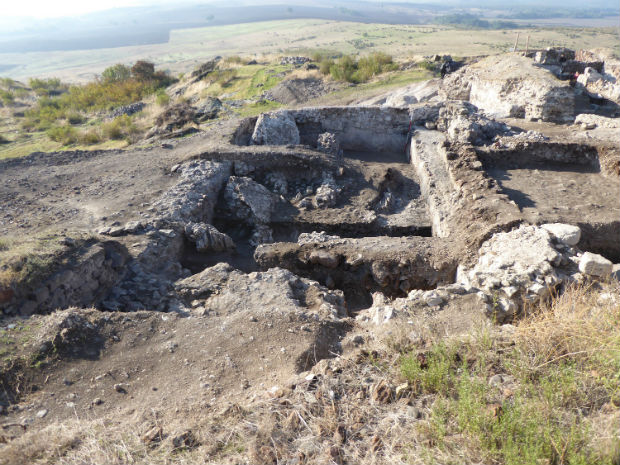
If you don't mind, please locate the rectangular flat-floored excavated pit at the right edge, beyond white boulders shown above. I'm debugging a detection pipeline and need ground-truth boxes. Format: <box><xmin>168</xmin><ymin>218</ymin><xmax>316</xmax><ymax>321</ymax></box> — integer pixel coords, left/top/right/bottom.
<box><xmin>479</xmin><ymin>143</ymin><xmax>620</xmax><ymax>263</ymax></box>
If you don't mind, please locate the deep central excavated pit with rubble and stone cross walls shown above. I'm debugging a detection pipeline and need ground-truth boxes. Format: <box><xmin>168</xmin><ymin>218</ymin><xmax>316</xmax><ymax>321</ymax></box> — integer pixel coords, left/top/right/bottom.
<box><xmin>186</xmin><ymin>118</ymin><xmax>456</xmax><ymax>310</ymax></box>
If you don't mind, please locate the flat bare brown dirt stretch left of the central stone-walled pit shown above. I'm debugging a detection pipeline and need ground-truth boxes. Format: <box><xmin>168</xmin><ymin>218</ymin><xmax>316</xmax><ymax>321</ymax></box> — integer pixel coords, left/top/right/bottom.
<box><xmin>0</xmin><ymin>120</ymin><xmax>236</xmax><ymax>236</ymax></box>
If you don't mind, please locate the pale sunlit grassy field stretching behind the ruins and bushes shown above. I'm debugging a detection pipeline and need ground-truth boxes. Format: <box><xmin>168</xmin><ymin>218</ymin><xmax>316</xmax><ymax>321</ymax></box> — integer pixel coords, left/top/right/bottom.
<box><xmin>0</xmin><ymin>19</ymin><xmax>620</xmax><ymax>82</ymax></box>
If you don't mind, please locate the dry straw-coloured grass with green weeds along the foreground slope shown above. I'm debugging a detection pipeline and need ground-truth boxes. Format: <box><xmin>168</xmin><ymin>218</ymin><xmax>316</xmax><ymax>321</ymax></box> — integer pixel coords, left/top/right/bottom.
<box><xmin>0</xmin><ymin>283</ymin><xmax>620</xmax><ymax>465</ymax></box>
